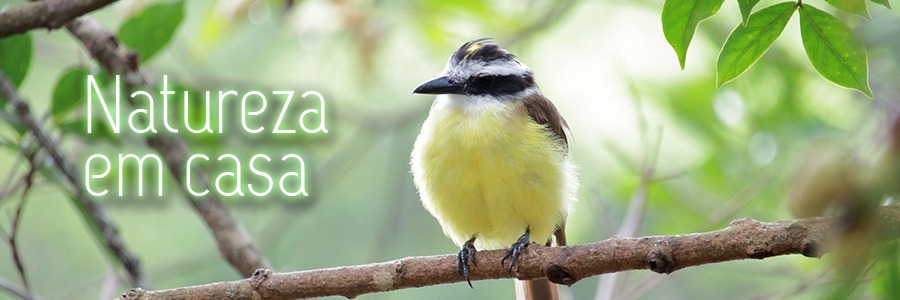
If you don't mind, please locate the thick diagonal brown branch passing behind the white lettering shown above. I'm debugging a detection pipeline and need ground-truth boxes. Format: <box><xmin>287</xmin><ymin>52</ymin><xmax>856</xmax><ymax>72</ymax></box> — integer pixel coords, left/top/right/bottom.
<box><xmin>66</xmin><ymin>17</ymin><xmax>268</xmax><ymax>277</ymax></box>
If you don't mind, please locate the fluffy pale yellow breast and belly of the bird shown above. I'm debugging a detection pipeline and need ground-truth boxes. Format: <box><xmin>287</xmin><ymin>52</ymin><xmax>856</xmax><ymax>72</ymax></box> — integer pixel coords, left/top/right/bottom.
<box><xmin>412</xmin><ymin>95</ymin><xmax>574</xmax><ymax>249</ymax></box>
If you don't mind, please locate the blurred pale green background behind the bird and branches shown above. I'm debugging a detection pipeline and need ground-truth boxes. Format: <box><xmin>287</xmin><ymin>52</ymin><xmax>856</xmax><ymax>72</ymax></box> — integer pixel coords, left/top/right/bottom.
<box><xmin>0</xmin><ymin>0</ymin><xmax>900</xmax><ymax>299</ymax></box>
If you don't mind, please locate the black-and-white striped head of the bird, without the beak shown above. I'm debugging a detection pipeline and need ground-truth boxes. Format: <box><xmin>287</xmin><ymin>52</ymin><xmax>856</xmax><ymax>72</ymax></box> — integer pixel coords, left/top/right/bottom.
<box><xmin>444</xmin><ymin>39</ymin><xmax>537</xmax><ymax>96</ymax></box>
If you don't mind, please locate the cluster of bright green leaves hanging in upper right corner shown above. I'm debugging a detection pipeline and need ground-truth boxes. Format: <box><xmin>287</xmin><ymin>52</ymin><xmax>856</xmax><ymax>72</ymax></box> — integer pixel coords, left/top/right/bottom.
<box><xmin>662</xmin><ymin>0</ymin><xmax>891</xmax><ymax>98</ymax></box>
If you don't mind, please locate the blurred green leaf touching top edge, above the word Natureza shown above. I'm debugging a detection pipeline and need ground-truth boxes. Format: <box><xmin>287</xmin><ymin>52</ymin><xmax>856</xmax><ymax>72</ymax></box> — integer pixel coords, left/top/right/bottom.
<box><xmin>118</xmin><ymin>0</ymin><xmax>184</xmax><ymax>62</ymax></box>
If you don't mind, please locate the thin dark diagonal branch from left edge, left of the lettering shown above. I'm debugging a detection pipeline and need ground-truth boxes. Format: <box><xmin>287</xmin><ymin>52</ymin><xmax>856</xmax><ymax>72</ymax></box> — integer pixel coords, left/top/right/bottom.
<box><xmin>0</xmin><ymin>72</ymin><xmax>146</xmax><ymax>286</ymax></box>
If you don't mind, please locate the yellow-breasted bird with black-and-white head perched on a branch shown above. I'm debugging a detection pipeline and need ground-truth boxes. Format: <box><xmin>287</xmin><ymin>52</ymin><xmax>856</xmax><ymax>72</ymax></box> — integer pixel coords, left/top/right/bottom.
<box><xmin>410</xmin><ymin>38</ymin><xmax>578</xmax><ymax>293</ymax></box>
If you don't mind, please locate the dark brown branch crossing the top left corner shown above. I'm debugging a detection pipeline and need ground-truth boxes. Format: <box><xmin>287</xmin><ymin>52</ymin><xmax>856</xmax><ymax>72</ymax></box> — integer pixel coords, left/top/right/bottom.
<box><xmin>0</xmin><ymin>0</ymin><xmax>116</xmax><ymax>39</ymax></box>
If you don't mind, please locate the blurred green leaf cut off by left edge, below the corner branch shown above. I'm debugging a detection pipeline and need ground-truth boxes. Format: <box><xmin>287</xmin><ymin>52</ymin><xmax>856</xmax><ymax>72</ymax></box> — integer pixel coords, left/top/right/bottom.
<box><xmin>0</xmin><ymin>33</ymin><xmax>32</xmax><ymax>105</ymax></box>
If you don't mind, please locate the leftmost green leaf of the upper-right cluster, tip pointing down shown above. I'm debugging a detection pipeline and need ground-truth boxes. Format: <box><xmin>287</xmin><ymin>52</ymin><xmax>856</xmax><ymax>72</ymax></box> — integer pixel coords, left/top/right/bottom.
<box><xmin>662</xmin><ymin>0</ymin><xmax>725</xmax><ymax>69</ymax></box>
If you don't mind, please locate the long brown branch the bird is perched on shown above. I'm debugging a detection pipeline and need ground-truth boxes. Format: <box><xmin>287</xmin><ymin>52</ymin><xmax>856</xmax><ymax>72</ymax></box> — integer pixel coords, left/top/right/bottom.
<box><xmin>121</xmin><ymin>205</ymin><xmax>900</xmax><ymax>300</ymax></box>
